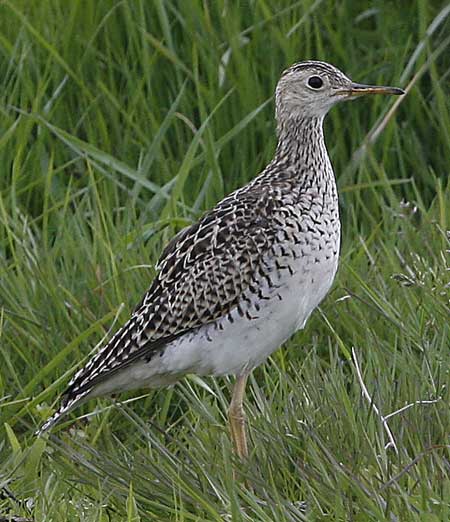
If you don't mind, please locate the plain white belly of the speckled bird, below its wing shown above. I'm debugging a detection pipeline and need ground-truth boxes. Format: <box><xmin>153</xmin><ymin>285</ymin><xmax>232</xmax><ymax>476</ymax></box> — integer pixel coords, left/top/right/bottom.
<box><xmin>92</xmin><ymin>257</ymin><xmax>337</xmax><ymax>395</ymax></box>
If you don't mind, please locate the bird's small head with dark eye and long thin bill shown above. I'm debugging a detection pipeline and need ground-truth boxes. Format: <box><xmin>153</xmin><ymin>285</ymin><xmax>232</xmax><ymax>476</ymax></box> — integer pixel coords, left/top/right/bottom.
<box><xmin>276</xmin><ymin>61</ymin><xmax>404</xmax><ymax>119</ymax></box>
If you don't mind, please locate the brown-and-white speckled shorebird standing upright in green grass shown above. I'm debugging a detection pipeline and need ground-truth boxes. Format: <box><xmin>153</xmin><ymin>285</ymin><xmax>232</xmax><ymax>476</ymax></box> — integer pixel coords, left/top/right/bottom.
<box><xmin>38</xmin><ymin>60</ymin><xmax>404</xmax><ymax>452</ymax></box>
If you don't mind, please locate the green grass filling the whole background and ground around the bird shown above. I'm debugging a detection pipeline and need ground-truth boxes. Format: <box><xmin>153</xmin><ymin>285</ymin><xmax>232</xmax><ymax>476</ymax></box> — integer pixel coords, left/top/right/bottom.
<box><xmin>0</xmin><ymin>0</ymin><xmax>450</xmax><ymax>522</ymax></box>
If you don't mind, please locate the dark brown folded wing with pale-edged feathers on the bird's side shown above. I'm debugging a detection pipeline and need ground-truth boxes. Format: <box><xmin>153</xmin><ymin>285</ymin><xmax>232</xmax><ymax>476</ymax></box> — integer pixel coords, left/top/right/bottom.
<box><xmin>59</xmin><ymin>187</ymin><xmax>277</xmax><ymax>403</ymax></box>
